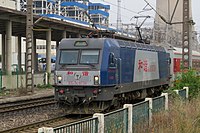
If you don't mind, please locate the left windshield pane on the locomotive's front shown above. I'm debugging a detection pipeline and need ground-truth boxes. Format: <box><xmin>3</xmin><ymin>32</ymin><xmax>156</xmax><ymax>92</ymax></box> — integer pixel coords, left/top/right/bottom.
<box><xmin>60</xmin><ymin>50</ymin><xmax>79</xmax><ymax>64</ymax></box>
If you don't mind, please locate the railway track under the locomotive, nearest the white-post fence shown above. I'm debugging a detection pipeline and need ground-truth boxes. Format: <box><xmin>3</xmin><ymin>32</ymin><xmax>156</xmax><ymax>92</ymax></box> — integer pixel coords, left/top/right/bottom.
<box><xmin>0</xmin><ymin>115</ymin><xmax>88</xmax><ymax>133</ymax></box>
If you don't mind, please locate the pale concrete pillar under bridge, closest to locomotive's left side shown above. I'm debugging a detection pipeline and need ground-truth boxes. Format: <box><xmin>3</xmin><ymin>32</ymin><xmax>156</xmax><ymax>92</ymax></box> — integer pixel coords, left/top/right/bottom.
<box><xmin>46</xmin><ymin>29</ymin><xmax>51</xmax><ymax>74</ymax></box>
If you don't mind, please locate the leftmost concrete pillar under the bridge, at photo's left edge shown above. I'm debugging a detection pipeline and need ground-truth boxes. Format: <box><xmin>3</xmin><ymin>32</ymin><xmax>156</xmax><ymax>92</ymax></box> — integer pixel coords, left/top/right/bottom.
<box><xmin>1</xmin><ymin>34</ymin><xmax>6</xmax><ymax>72</ymax></box>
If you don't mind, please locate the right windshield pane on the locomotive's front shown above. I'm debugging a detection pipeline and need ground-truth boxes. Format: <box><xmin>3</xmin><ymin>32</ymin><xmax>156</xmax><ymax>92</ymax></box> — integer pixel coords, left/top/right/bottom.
<box><xmin>80</xmin><ymin>50</ymin><xmax>99</xmax><ymax>64</ymax></box>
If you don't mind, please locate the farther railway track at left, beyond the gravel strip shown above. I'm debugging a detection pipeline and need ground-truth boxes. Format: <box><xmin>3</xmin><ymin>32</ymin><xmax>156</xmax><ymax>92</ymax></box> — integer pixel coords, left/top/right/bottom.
<box><xmin>0</xmin><ymin>96</ymin><xmax>56</xmax><ymax>114</ymax></box>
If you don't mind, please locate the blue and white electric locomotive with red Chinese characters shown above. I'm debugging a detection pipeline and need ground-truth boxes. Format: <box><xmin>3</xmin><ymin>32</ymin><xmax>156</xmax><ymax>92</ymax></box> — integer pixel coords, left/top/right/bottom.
<box><xmin>54</xmin><ymin>38</ymin><xmax>170</xmax><ymax>114</ymax></box>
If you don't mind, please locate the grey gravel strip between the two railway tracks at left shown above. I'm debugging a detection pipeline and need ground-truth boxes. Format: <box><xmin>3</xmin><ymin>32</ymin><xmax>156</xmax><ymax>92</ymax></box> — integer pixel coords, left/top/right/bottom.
<box><xmin>0</xmin><ymin>105</ymin><xmax>63</xmax><ymax>131</ymax></box>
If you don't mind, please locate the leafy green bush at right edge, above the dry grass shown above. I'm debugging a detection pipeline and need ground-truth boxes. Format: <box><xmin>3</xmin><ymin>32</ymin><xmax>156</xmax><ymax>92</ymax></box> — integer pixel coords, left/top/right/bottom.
<box><xmin>171</xmin><ymin>69</ymin><xmax>200</xmax><ymax>98</ymax></box>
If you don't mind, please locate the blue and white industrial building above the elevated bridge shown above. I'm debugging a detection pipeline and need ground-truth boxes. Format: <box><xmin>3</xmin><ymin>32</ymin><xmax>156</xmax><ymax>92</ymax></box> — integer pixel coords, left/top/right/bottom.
<box><xmin>27</xmin><ymin>0</ymin><xmax>110</xmax><ymax>28</ymax></box>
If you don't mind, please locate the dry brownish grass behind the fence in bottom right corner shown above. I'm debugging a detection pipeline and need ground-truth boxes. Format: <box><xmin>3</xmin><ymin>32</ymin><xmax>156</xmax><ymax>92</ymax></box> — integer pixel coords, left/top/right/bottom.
<box><xmin>139</xmin><ymin>96</ymin><xmax>200</xmax><ymax>133</ymax></box>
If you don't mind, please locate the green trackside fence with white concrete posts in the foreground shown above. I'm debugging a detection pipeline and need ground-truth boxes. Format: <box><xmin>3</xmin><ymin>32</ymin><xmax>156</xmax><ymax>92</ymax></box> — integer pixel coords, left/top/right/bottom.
<box><xmin>38</xmin><ymin>87</ymin><xmax>189</xmax><ymax>133</ymax></box>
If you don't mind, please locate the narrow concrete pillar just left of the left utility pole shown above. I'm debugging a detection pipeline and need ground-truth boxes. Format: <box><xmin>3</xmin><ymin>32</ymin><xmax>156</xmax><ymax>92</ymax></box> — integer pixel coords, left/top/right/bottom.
<box><xmin>17</xmin><ymin>36</ymin><xmax>22</xmax><ymax>73</ymax></box>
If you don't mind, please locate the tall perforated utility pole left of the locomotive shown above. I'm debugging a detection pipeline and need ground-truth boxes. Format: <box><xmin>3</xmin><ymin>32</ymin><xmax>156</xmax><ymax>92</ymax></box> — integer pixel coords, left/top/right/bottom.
<box><xmin>26</xmin><ymin>0</ymin><xmax>34</xmax><ymax>93</ymax></box>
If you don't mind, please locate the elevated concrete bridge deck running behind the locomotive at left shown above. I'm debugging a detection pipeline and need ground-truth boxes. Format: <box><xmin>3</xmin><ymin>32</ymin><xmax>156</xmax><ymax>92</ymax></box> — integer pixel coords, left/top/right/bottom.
<box><xmin>0</xmin><ymin>7</ymin><xmax>134</xmax><ymax>41</ymax></box>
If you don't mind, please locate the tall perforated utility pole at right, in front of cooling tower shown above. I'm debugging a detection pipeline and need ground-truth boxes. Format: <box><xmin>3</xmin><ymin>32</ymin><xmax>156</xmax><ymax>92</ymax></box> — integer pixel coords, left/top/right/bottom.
<box><xmin>182</xmin><ymin>0</ymin><xmax>192</xmax><ymax>70</ymax></box>
